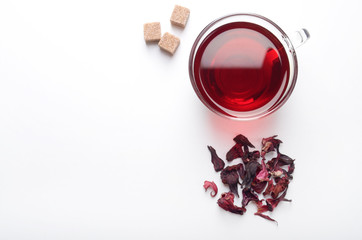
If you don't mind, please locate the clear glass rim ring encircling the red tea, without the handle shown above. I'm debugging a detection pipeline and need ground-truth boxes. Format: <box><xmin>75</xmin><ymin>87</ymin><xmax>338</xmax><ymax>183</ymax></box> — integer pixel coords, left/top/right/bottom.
<box><xmin>188</xmin><ymin>13</ymin><xmax>298</xmax><ymax>121</ymax></box>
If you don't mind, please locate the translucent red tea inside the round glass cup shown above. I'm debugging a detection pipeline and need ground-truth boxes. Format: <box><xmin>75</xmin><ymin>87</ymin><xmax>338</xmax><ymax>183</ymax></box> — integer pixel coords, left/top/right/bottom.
<box><xmin>194</xmin><ymin>22</ymin><xmax>289</xmax><ymax>112</ymax></box>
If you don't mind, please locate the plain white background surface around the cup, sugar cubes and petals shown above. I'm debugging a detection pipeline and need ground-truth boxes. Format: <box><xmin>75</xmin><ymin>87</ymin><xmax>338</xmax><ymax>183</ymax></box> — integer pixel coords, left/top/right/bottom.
<box><xmin>0</xmin><ymin>0</ymin><xmax>362</xmax><ymax>240</ymax></box>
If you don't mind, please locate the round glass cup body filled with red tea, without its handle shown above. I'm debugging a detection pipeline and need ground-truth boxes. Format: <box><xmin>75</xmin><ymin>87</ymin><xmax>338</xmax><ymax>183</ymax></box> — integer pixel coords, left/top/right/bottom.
<box><xmin>189</xmin><ymin>14</ymin><xmax>298</xmax><ymax>120</ymax></box>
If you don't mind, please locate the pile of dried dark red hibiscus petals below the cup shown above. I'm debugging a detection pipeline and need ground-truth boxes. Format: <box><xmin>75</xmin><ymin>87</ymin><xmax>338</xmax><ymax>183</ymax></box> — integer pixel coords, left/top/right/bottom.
<box><xmin>204</xmin><ymin>134</ymin><xmax>294</xmax><ymax>221</ymax></box>
